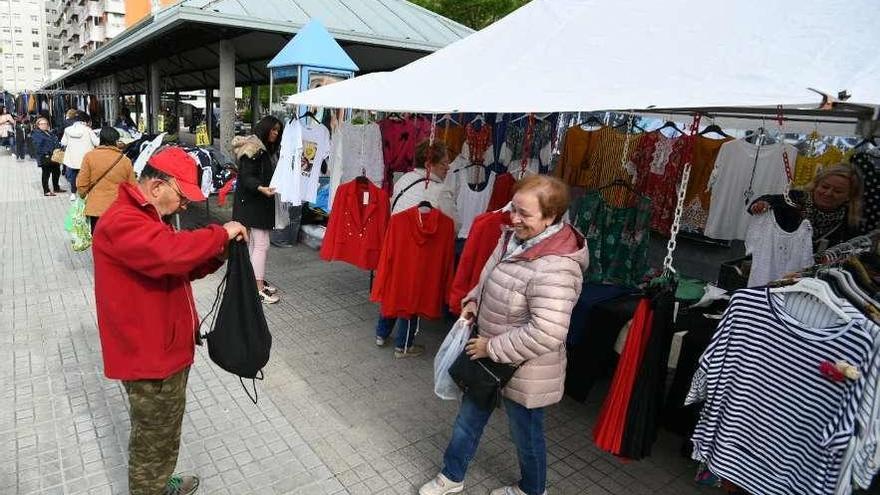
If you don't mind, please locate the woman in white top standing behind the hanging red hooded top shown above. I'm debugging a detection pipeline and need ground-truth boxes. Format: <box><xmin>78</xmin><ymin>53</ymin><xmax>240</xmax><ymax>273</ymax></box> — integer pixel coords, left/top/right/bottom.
<box><xmin>376</xmin><ymin>141</ymin><xmax>458</xmax><ymax>358</ymax></box>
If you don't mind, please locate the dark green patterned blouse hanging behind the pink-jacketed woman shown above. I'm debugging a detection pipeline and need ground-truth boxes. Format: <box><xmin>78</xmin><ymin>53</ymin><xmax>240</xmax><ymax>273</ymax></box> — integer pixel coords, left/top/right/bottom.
<box><xmin>573</xmin><ymin>191</ymin><xmax>651</xmax><ymax>286</ymax></box>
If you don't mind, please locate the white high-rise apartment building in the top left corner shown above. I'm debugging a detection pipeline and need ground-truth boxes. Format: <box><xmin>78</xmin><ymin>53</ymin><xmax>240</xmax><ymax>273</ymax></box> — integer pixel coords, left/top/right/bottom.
<box><xmin>0</xmin><ymin>0</ymin><xmax>46</xmax><ymax>92</ymax></box>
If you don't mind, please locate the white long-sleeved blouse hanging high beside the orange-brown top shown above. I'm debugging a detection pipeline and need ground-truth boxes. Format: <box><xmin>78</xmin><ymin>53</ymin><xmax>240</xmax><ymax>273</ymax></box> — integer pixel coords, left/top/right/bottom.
<box><xmin>704</xmin><ymin>139</ymin><xmax>797</xmax><ymax>240</ymax></box>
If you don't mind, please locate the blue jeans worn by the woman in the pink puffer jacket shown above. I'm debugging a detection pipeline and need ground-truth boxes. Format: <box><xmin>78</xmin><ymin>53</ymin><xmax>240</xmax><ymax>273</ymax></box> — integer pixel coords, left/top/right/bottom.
<box><xmin>441</xmin><ymin>396</ymin><xmax>547</xmax><ymax>495</ymax></box>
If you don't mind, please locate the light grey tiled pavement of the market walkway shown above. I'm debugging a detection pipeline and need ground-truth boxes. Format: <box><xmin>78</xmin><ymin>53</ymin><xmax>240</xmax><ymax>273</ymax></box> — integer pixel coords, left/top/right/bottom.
<box><xmin>0</xmin><ymin>151</ymin><xmax>711</xmax><ymax>495</ymax></box>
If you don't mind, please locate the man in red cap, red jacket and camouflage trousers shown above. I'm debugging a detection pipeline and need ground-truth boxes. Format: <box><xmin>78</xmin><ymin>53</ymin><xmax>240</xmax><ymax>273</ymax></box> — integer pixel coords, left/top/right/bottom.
<box><xmin>92</xmin><ymin>148</ymin><xmax>247</xmax><ymax>495</ymax></box>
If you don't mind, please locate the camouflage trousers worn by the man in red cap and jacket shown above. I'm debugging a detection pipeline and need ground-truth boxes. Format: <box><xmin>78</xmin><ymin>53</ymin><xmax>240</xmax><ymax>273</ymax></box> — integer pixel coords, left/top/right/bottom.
<box><xmin>122</xmin><ymin>368</ymin><xmax>189</xmax><ymax>495</ymax></box>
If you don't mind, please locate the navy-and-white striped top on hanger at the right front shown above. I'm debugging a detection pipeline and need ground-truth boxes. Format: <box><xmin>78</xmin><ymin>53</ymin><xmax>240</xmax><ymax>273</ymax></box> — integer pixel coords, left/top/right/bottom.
<box><xmin>686</xmin><ymin>289</ymin><xmax>875</xmax><ymax>495</ymax></box>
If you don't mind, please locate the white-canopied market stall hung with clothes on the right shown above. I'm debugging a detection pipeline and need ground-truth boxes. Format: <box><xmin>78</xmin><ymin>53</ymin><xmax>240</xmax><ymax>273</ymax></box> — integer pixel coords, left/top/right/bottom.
<box><xmin>276</xmin><ymin>0</ymin><xmax>880</xmax><ymax>493</ymax></box>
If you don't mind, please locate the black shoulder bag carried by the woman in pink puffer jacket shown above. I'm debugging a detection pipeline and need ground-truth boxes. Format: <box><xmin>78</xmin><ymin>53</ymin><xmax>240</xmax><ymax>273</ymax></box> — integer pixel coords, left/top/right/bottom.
<box><xmin>449</xmin><ymin>237</ymin><xmax>519</xmax><ymax>411</ymax></box>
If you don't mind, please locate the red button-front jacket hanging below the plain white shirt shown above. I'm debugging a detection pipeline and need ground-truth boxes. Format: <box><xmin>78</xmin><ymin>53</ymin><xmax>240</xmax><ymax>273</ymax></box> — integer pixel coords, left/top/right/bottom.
<box><xmin>321</xmin><ymin>180</ymin><xmax>389</xmax><ymax>270</ymax></box>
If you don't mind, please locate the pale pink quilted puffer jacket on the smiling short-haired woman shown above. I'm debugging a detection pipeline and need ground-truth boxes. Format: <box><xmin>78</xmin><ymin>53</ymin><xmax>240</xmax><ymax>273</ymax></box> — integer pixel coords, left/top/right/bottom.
<box><xmin>462</xmin><ymin>225</ymin><xmax>588</xmax><ymax>409</ymax></box>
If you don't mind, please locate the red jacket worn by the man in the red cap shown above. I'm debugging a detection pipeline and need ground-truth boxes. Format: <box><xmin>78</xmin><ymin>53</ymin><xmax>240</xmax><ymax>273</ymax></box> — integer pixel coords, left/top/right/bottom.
<box><xmin>92</xmin><ymin>184</ymin><xmax>228</xmax><ymax>380</ymax></box>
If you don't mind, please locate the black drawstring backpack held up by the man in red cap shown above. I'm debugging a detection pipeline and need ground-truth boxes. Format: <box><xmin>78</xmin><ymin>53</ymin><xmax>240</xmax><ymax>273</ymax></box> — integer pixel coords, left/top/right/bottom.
<box><xmin>202</xmin><ymin>241</ymin><xmax>272</xmax><ymax>404</ymax></box>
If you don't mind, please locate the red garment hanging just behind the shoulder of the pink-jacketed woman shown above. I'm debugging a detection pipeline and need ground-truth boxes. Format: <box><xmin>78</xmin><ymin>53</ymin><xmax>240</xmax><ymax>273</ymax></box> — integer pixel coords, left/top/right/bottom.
<box><xmin>447</xmin><ymin>210</ymin><xmax>510</xmax><ymax>314</ymax></box>
